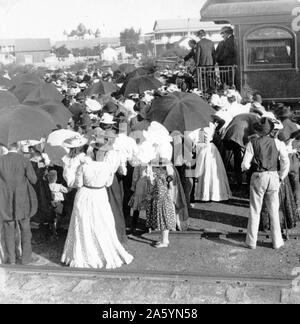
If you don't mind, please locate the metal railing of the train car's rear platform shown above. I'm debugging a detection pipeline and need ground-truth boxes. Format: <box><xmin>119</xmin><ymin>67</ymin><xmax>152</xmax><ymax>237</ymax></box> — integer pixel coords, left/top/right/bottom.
<box><xmin>197</xmin><ymin>65</ymin><xmax>236</xmax><ymax>93</ymax></box>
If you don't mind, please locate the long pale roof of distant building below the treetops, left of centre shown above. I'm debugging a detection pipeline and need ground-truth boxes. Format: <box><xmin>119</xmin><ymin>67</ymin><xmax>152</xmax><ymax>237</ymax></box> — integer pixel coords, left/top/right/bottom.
<box><xmin>55</xmin><ymin>37</ymin><xmax>120</xmax><ymax>50</ymax></box>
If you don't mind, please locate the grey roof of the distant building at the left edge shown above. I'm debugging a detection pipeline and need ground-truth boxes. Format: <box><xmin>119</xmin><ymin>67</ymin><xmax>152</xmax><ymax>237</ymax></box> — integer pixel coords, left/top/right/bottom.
<box><xmin>0</xmin><ymin>38</ymin><xmax>51</xmax><ymax>53</ymax></box>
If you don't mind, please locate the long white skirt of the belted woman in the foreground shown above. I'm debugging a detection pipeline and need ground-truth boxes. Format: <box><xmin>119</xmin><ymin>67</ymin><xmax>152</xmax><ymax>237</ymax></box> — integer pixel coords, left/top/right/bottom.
<box><xmin>61</xmin><ymin>187</ymin><xmax>133</xmax><ymax>269</ymax></box>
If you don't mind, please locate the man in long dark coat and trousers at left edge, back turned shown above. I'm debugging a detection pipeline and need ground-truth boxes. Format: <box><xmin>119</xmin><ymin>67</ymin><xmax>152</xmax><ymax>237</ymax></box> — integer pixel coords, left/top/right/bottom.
<box><xmin>0</xmin><ymin>144</ymin><xmax>38</xmax><ymax>265</ymax></box>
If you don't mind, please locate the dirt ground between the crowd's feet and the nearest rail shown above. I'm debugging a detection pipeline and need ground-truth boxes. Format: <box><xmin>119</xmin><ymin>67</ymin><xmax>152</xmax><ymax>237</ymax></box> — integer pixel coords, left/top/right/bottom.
<box><xmin>28</xmin><ymin>196</ymin><xmax>300</xmax><ymax>277</ymax></box>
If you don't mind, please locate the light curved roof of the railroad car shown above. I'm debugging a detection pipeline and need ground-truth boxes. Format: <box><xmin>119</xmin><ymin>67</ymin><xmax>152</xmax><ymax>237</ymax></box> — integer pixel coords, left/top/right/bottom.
<box><xmin>200</xmin><ymin>0</ymin><xmax>300</xmax><ymax>24</ymax></box>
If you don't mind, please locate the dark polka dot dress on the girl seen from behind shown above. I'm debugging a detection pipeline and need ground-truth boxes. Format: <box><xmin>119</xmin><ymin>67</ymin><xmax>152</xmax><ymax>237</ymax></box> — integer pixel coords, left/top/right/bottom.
<box><xmin>146</xmin><ymin>168</ymin><xmax>176</xmax><ymax>231</ymax></box>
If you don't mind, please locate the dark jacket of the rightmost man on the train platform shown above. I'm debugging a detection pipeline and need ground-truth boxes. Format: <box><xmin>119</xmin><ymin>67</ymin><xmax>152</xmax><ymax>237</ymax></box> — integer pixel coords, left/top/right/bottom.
<box><xmin>216</xmin><ymin>36</ymin><xmax>237</xmax><ymax>66</ymax></box>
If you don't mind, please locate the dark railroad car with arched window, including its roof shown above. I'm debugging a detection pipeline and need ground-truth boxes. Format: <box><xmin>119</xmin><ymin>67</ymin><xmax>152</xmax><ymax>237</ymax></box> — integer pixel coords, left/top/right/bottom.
<box><xmin>200</xmin><ymin>0</ymin><xmax>300</xmax><ymax>104</ymax></box>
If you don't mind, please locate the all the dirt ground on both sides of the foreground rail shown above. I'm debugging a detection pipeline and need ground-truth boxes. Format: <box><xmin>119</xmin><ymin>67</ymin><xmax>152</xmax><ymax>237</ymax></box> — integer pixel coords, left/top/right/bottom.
<box><xmin>0</xmin><ymin>187</ymin><xmax>300</xmax><ymax>304</ymax></box>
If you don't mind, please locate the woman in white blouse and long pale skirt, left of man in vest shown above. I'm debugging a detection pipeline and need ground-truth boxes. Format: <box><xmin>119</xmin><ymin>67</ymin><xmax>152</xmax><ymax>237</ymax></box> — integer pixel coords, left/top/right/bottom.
<box><xmin>190</xmin><ymin>123</ymin><xmax>232</xmax><ymax>202</ymax></box>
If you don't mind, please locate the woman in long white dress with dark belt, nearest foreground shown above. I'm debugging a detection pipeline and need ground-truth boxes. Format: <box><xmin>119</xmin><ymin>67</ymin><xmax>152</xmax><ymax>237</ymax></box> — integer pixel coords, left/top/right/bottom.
<box><xmin>61</xmin><ymin>134</ymin><xmax>133</xmax><ymax>269</ymax></box>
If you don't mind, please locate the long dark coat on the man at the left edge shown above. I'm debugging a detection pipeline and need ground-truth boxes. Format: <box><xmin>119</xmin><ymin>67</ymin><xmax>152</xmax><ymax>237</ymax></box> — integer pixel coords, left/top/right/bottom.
<box><xmin>0</xmin><ymin>152</ymin><xmax>38</xmax><ymax>221</ymax></box>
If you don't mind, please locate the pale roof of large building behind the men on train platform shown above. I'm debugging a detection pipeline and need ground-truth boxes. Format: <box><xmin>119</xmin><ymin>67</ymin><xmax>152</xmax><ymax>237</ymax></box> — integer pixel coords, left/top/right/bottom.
<box><xmin>153</xmin><ymin>18</ymin><xmax>226</xmax><ymax>33</ymax></box>
